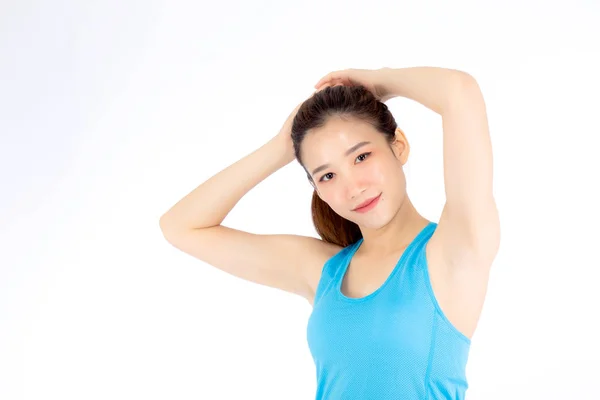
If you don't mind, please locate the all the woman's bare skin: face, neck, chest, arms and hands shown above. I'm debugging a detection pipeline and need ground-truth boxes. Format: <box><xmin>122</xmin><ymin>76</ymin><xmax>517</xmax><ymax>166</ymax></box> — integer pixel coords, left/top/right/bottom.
<box><xmin>160</xmin><ymin>67</ymin><xmax>500</xmax><ymax>338</ymax></box>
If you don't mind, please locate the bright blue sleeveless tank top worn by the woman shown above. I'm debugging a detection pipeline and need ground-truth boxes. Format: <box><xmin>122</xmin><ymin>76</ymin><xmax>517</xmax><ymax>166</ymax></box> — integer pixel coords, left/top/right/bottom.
<box><xmin>307</xmin><ymin>222</ymin><xmax>471</xmax><ymax>400</ymax></box>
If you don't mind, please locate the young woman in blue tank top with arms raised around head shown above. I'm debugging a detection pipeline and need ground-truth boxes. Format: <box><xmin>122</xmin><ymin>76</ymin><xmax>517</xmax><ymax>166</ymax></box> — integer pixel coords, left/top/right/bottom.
<box><xmin>160</xmin><ymin>67</ymin><xmax>500</xmax><ymax>399</ymax></box>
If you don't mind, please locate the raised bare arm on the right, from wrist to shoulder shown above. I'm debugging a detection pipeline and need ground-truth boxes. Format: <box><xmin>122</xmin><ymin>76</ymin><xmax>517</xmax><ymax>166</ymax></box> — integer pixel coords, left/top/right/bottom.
<box><xmin>382</xmin><ymin>67</ymin><xmax>500</xmax><ymax>267</ymax></box>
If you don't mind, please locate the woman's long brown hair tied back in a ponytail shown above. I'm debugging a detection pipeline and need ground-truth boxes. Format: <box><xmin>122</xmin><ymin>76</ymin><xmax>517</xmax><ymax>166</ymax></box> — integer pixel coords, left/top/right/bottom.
<box><xmin>292</xmin><ymin>85</ymin><xmax>398</xmax><ymax>247</ymax></box>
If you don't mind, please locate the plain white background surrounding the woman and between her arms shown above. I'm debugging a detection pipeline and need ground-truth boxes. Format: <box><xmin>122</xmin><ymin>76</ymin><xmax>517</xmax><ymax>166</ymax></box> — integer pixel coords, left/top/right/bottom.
<box><xmin>0</xmin><ymin>0</ymin><xmax>600</xmax><ymax>400</ymax></box>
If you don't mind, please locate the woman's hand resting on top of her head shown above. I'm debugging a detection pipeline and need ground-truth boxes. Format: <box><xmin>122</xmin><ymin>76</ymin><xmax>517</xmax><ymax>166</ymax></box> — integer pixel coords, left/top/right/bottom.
<box><xmin>315</xmin><ymin>68</ymin><xmax>396</xmax><ymax>102</ymax></box>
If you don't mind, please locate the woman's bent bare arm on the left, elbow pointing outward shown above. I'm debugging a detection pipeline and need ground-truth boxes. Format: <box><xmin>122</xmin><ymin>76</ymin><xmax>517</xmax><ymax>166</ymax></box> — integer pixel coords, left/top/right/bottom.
<box><xmin>160</xmin><ymin>128</ymin><xmax>337</xmax><ymax>303</ymax></box>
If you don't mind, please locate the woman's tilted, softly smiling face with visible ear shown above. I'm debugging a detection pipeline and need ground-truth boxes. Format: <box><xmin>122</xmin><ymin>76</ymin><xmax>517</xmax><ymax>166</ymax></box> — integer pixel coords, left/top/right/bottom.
<box><xmin>302</xmin><ymin>117</ymin><xmax>409</xmax><ymax>228</ymax></box>
